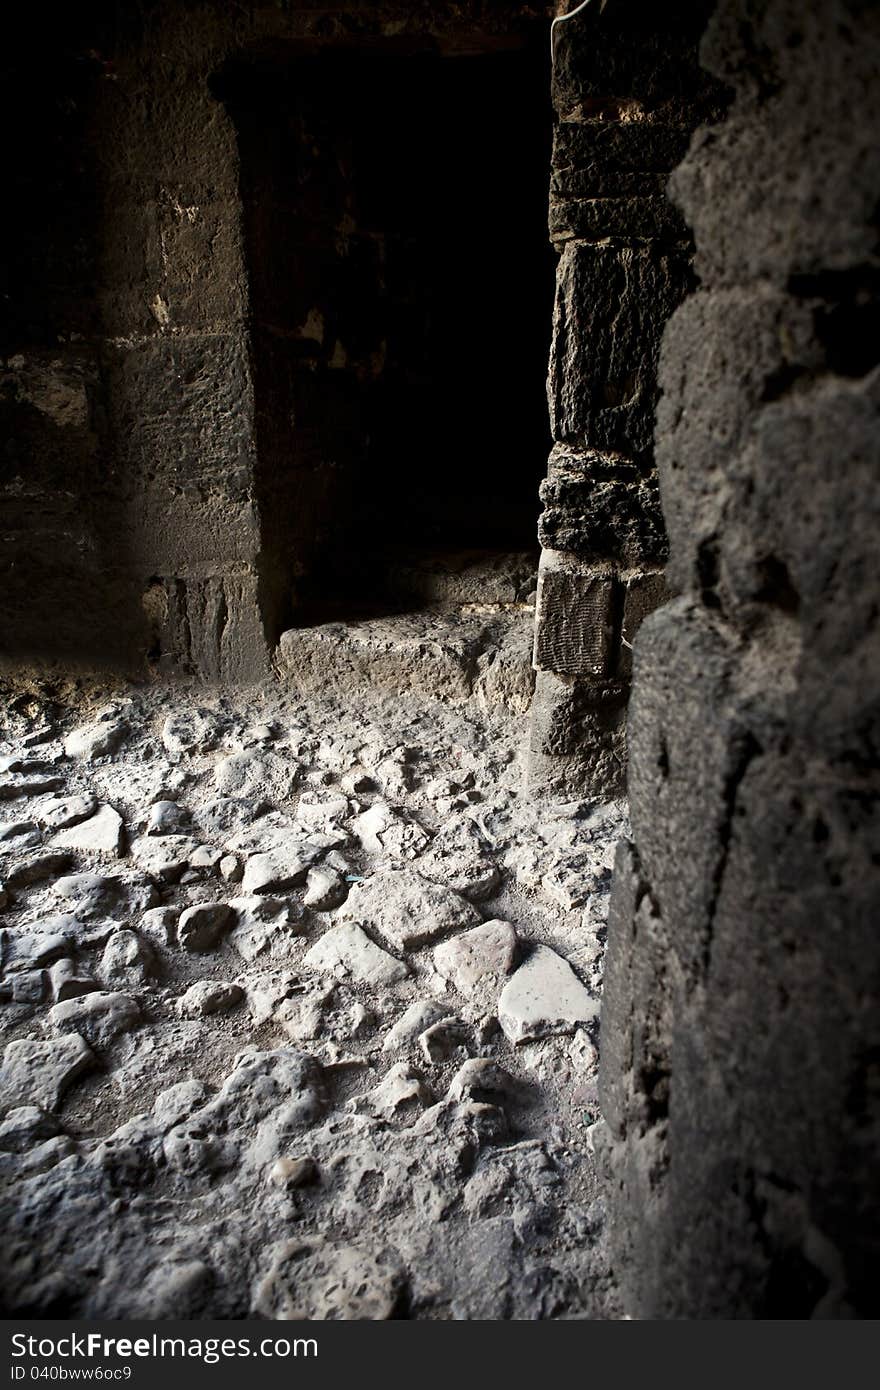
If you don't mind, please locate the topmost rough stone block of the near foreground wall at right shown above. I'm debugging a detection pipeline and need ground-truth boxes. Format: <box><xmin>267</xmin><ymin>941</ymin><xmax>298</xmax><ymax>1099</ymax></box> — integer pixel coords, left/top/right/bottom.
<box><xmin>671</xmin><ymin>0</ymin><xmax>880</xmax><ymax>285</ymax></box>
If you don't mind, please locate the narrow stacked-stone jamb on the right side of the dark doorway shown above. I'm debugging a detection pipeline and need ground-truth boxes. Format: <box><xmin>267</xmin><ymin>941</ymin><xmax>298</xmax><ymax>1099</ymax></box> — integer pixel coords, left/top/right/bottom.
<box><xmin>530</xmin><ymin>0</ymin><xmax>722</xmax><ymax>794</ymax></box>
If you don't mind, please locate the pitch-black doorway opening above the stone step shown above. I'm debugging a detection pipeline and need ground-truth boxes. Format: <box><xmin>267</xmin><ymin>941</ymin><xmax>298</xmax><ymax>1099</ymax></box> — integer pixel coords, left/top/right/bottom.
<box><xmin>220</xmin><ymin>38</ymin><xmax>555</xmax><ymax>636</ymax></box>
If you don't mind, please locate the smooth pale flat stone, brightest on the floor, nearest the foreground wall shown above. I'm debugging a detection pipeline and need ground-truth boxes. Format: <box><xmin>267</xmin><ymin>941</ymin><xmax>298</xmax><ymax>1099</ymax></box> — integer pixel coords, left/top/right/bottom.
<box><xmin>498</xmin><ymin>947</ymin><xmax>599</xmax><ymax>1043</ymax></box>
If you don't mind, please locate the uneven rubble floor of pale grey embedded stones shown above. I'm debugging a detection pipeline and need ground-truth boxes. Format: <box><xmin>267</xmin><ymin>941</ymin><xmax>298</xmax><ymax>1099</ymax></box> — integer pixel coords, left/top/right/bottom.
<box><xmin>0</xmin><ymin>685</ymin><xmax>627</xmax><ymax>1319</ymax></box>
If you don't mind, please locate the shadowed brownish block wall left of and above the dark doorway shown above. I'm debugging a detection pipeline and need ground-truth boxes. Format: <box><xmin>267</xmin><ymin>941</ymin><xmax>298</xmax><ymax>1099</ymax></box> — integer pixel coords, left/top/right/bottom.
<box><xmin>0</xmin><ymin>0</ymin><xmax>549</xmax><ymax>681</ymax></box>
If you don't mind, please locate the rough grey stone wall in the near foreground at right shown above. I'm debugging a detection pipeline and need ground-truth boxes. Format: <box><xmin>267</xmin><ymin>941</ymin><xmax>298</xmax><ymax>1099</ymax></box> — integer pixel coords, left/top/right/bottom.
<box><xmin>601</xmin><ymin>0</ymin><xmax>880</xmax><ymax>1318</ymax></box>
